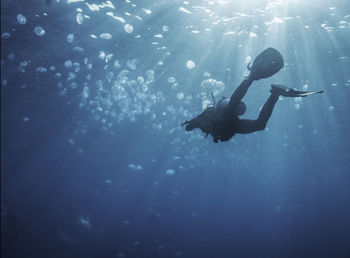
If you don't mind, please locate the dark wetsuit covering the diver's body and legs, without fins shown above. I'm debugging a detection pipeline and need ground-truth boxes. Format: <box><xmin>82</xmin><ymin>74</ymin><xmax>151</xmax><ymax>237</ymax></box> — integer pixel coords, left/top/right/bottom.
<box><xmin>184</xmin><ymin>74</ymin><xmax>280</xmax><ymax>142</ymax></box>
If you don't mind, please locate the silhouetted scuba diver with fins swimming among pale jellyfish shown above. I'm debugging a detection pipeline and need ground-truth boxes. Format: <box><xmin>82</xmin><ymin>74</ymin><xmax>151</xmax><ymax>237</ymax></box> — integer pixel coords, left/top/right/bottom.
<box><xmin>181</xmin><ymin>48</ymin><xmax>323</xmax><ymax>143</ymax></box>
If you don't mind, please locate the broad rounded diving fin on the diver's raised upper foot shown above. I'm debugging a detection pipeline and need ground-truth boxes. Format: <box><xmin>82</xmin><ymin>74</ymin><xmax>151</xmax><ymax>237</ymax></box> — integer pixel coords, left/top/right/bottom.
<box><xmin>247</xmin><ymin>47</ymin><xmax>284</xmax><ymax>80</ymax></box>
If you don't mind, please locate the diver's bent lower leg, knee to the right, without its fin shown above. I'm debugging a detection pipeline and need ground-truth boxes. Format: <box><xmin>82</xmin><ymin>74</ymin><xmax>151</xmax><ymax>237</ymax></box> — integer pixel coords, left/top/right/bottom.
<box><xmin>236</xmin><ymin>93</ymin><xmax>280</xmax><ymax>134</ymax></box>
